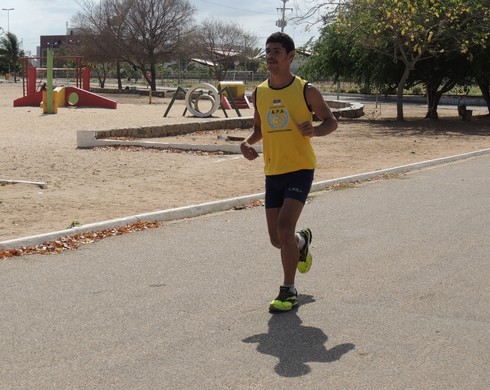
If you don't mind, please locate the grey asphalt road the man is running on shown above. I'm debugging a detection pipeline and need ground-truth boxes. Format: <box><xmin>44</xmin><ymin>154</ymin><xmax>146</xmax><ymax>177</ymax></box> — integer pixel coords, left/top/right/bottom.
<box><xmin>0</xmin><ymin>155</ymin><xmax>490</xmax><ymax>390</ymax></box>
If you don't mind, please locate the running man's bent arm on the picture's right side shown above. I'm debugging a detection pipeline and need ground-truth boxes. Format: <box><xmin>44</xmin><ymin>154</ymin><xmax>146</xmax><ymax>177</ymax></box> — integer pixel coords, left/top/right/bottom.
<box><xmin>298</xmin><ymin>84</ymin><xmax>338</xmax><ymax>137</ymax></box>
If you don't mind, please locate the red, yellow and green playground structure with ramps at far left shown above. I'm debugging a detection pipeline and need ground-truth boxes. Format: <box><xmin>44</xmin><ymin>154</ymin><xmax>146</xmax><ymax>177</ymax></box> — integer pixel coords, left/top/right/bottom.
<box><xmin>14</xmin><ymin>49</ymin><xmax>117</xmax><ymax>114</ymax></box>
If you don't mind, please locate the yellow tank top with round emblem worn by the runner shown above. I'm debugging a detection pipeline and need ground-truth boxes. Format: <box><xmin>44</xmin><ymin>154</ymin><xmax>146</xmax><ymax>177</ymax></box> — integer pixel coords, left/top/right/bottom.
<box><xmin>255</xmin><ymin>76</ymin><xmax>316</xmax><ymax>176</ymax></box>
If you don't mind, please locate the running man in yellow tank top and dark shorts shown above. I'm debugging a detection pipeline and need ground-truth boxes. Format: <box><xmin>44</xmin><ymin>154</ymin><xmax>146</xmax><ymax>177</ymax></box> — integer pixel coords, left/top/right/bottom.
<box><xmin>240</xmin><ymin>32</ymin><xmax>337</xmax><ymax>312</ymax></box>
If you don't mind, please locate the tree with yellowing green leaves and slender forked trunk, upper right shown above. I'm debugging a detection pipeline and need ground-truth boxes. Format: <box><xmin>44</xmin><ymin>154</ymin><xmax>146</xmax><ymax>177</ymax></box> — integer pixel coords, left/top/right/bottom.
<box><xmin>336</xmin><ymin>0</ymin><xmax>490</xmax><ymax>120</ymax></box>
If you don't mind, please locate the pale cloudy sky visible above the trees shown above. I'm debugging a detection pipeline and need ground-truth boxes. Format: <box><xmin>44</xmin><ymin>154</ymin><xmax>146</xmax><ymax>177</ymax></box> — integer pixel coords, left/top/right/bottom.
<box><xmin>0</xmin><ymin>0</ymin><xmax>317</xmax><ymax>56</ymax></box>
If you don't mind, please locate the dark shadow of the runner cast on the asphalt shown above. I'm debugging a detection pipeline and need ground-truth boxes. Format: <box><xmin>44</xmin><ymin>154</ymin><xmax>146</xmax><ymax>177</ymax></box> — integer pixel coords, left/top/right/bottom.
<box><xmin>243</xmin><ymin>295</ymin><xmax>355</xmax><ymax>377</ymax></box>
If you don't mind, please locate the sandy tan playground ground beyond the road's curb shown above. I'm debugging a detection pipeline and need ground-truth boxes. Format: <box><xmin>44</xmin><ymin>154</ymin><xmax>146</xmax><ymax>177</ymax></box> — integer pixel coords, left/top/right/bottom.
<box><xmin>0</xmin><ymin>83</ymin><xmax>490</xmax><ymax>241</ymax></box>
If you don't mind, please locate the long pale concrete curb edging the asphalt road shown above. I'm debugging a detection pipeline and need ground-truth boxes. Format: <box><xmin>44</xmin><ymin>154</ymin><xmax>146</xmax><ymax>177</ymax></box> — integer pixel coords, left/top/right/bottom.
<box><xmin>0</xmin><ymin>148</ymin><xmax>490</xmax><ymax>250</ymax></box>
